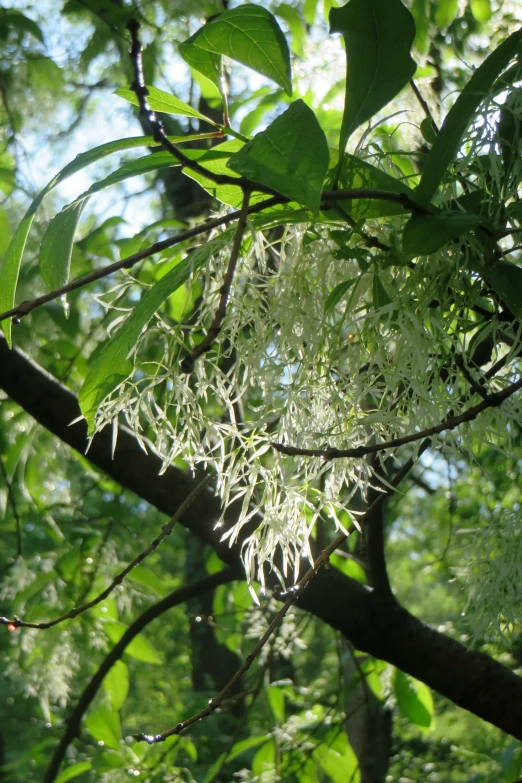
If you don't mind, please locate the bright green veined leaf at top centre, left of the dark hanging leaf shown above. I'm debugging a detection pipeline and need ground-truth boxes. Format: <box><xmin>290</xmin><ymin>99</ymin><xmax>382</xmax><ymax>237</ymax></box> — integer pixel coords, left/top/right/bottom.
<box><xmin>185</xmin><ymin>3</ymin><xmax>292</xmax><ymax>95</ymax></box>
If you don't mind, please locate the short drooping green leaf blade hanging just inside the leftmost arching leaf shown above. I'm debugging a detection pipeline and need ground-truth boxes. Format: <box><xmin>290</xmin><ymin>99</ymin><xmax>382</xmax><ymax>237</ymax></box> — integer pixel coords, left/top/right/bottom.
<box><xmin>40</xmin><ymin>201</ymin><xmax>86</xmax><ymax>290</ymax></box>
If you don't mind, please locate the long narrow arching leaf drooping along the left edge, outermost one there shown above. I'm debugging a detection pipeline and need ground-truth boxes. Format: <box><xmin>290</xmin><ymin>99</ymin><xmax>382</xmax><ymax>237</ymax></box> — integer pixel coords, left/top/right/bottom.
<box><xmin>0</xmin><ymin>136</ymin><xmax>177</xmax><ymax>345</ymax></box>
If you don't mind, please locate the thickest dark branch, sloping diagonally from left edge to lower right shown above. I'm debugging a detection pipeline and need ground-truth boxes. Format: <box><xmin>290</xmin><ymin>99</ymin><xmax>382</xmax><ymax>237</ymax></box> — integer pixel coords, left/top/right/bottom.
<box><xmin>0</xmin><ymin>338</ymin><xmax>522</xmax><ymax>740</ymax></box>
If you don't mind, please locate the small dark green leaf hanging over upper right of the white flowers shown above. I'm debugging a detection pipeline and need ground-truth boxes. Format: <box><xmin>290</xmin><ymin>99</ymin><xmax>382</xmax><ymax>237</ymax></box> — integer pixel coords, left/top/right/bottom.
<box><xmin>402</xmin><ymin>212</ymin><xmax>483</xmax><ymax>256</ymax></box>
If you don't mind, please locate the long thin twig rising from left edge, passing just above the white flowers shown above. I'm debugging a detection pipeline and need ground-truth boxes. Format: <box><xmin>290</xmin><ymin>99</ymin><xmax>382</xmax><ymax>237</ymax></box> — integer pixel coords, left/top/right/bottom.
<box><xmin>0</xmin><ymin>190</ymin><xmax>431</xmax><ymax>323</ymax></box>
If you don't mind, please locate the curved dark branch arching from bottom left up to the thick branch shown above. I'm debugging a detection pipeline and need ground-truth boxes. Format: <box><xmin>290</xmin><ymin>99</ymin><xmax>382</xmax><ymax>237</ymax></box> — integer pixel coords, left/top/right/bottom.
<box><xmin>43</xmin><ymin>568</ymin><xmax>237</xmax><ymax>783</ymax></box>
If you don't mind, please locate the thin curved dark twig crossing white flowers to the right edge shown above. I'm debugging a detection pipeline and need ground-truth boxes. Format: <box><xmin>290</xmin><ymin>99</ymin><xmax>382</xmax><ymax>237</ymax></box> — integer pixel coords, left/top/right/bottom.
<box><xmin>270</xmin><ymin>378</ymin><xmax>522</xmax><ymax>460</ymax></box>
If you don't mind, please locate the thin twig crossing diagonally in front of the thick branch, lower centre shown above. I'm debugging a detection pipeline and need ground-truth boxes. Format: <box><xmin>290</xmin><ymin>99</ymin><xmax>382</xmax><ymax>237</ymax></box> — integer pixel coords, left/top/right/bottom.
<box><xmin>132</xmin><ymin>438</ymin><xmax>422</xmax><ymax>745</ymax></box>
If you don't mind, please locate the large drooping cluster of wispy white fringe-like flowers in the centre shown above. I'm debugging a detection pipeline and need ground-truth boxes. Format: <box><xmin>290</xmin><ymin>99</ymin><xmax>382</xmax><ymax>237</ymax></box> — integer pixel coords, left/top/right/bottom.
<box><xmin>91</xmin><ymin>208</ymin><xmax>517</xmax><ymax>582</ymax></box>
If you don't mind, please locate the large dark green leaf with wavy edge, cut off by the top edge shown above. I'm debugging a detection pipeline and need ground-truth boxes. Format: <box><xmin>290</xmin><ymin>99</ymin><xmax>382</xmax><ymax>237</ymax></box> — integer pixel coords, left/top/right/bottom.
<box><xmin>330</xmin><ymin>0</ymin><xmax>416</xmax><ymax>151</ymax></box>
